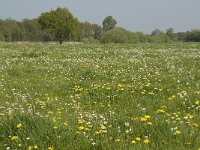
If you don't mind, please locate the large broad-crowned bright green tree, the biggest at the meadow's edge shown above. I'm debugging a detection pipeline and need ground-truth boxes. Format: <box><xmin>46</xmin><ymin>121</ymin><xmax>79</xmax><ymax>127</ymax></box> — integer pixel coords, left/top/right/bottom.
<box><xmin>39</xmin><ymin>8</ymin><xmax>78</xmax><ymax>44</ymax></box>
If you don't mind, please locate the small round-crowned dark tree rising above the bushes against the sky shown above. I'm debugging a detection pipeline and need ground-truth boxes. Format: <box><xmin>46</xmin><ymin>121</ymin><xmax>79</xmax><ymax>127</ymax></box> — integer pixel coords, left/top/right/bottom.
<box><xmin>103</xmin><ymin>16</ymin><xmax>117</xmax><ymax>31</ymax></box>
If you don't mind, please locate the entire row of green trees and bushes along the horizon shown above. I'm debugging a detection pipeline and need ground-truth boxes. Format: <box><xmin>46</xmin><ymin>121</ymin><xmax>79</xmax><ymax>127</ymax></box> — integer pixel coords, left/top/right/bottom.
<box><xmin>0</xmin><ymin>8</ymin><xmax>200</xmax><ymax>44</ymax></box>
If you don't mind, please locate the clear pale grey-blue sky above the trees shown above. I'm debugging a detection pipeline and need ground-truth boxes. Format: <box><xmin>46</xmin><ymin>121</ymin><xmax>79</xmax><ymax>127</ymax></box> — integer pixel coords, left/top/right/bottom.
<box><xmin>0</xmin><ymin>0</ymin><xmax>200</xmax><ymax>33</ymax></box>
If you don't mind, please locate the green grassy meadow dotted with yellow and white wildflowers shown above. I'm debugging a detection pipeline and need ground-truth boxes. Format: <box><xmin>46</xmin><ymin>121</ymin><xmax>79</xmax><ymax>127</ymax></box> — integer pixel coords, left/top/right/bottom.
<box><xmin>0</xmin><ymin>43</ymin><xmax>200</xmax><ymax>150</ymax></box>
